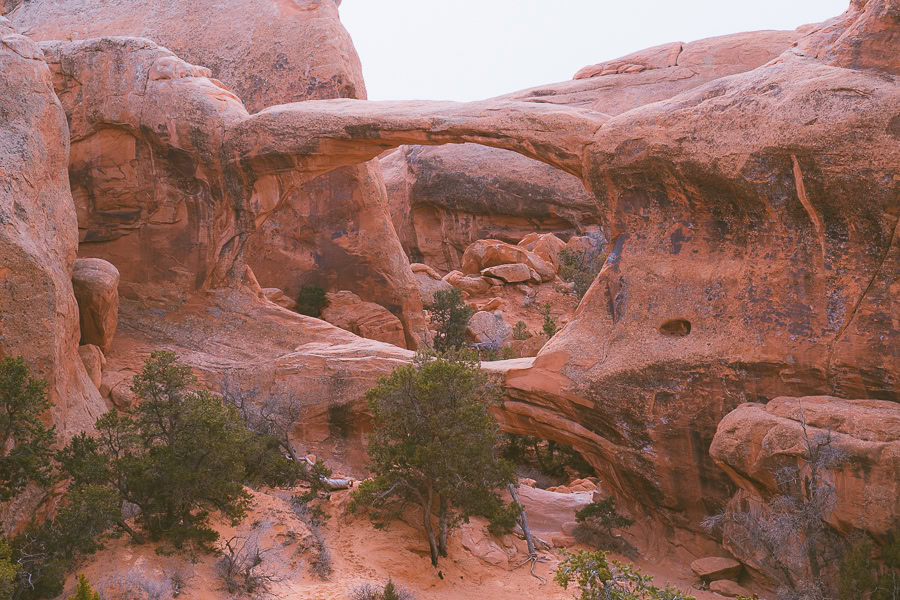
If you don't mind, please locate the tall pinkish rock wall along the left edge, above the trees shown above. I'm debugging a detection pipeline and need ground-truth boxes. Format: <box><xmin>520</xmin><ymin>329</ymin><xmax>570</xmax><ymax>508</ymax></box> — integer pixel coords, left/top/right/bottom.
<box><xmin>0</xmin><ymin>22</ymin><xmax>105</xmax><ymax>439</ymax></box>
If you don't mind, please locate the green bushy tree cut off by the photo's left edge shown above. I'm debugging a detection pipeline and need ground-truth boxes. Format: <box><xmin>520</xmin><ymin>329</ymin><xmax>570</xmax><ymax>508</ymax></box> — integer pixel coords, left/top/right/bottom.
<box><xmin>0</xmin><ymin>356</ymin><xmax>55</xmax><ymax>502</ymax></box>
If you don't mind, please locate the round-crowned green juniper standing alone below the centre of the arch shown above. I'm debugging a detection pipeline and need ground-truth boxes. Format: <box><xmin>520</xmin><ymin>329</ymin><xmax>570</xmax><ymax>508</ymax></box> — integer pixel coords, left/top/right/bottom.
<box><xmin>354</xmin><ymin>353</ymin><xmax>515</xmax><ymax>565</ymax></box>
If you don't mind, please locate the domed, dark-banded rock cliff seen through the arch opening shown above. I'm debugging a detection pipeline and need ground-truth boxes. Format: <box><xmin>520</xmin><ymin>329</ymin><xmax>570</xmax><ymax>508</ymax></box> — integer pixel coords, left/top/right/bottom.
<box><xmin>381</xmin><ymin>144</ymin><xmax>597</xmax><ymax>272</ymax></box>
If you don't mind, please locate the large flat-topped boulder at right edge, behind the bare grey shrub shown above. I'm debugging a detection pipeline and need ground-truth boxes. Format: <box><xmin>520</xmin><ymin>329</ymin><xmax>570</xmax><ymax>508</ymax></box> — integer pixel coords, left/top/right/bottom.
<box><xmin>710</xmin><ymin>396</ymin><xmax>900</xmax><ymax>542</ymax></box>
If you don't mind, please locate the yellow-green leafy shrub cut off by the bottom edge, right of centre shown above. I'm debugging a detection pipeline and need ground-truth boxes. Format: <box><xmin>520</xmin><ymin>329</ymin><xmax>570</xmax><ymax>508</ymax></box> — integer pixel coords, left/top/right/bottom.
<box><xmin>555</xmin><ymin>550</ymin><xmax>696</xmax><ymax>600</ymax></box>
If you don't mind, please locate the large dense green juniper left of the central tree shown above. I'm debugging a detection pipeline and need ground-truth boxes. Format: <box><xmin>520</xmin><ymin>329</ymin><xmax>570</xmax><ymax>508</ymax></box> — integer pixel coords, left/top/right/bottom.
<box><xmin>63</xmin><ymin>351</ymin><xmax>253</xmax><ymax>549</ymax></box>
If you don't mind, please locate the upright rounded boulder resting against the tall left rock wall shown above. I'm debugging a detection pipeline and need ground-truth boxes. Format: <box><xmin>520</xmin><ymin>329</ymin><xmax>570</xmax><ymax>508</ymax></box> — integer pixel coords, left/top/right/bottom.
<box><xmin>72</xmin><ymin>258</ymin><xmax>119</xmax><ymax>352</ymax></box>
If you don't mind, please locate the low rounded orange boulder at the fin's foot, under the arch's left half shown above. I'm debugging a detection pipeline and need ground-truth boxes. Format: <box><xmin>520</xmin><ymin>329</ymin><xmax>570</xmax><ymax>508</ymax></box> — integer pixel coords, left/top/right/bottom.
<box><xmin>322</xmin><ymin>291</ymin><xmax>406</xmax><ymax>348</ymax></box>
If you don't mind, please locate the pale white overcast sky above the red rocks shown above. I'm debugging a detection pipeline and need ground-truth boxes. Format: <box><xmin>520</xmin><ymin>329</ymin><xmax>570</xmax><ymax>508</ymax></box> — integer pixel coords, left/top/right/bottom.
<box><xmin>340</xmin><ymin>0</ymin><xmax>849</xmax><ymax>100</ymax></box>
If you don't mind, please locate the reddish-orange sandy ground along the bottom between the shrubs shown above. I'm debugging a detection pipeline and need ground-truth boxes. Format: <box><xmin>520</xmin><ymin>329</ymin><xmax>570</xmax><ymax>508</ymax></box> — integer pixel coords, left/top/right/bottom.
<box><xmin>63</xmin><ymin>492</ymin><xmax>722</xmax><ymax>600</ymax></box>
